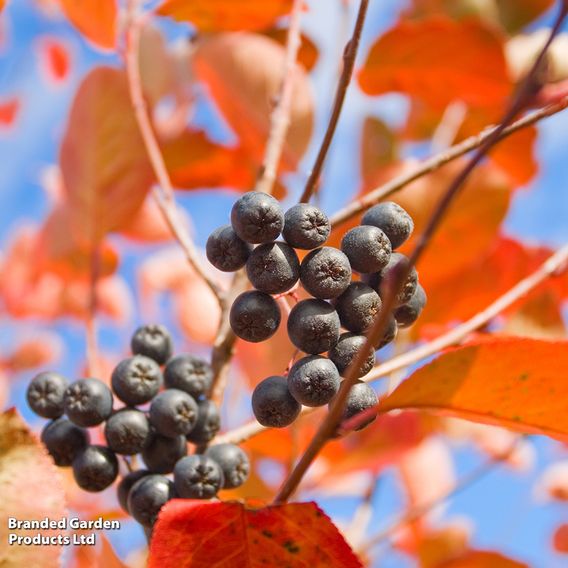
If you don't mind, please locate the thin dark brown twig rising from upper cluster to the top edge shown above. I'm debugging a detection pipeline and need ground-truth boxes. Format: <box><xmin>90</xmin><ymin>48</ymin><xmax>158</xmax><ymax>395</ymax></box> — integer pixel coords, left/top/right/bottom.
<box><xmin>300</xmin><ymin>0</ymin><xmax>369</xmax><ymax>203</ymax></box>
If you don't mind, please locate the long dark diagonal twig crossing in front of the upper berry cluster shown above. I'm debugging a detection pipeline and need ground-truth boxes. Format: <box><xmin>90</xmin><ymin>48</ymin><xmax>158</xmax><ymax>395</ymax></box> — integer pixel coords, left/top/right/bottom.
<box><xmin>274</xmin><ymin>5</ymin><xmax>567</xmax><ymax>503</ymax></box>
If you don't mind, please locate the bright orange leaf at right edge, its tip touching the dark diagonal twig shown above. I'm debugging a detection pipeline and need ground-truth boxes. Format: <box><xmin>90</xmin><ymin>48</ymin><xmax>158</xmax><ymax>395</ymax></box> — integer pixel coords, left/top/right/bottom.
<box><xmin>381</xmin><ymin>338</ymin><xmax>568</xmax><ymax>440</ymax></box>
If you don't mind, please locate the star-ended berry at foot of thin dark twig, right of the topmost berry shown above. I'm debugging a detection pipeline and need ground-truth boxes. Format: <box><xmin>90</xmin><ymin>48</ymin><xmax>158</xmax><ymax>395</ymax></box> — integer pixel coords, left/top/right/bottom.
<box><xmin>282</xmin><ymin>203</ymin><xmax>331</xmax><ymax>250</ymax></box>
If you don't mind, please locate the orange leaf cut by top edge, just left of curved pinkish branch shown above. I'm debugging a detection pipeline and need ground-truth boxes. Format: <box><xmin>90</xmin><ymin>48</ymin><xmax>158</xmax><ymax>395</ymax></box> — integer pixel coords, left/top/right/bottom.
<box><xmin>59</xmin><ymin>0</ymin><xmax>117</xmax><ymax>49</ymax></box>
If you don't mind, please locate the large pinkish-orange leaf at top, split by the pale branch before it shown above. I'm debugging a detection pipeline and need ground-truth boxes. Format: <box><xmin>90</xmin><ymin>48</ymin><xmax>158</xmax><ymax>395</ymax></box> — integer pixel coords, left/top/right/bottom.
<box><xmin>193</xmin><ymin>31</ymin><xmax>314</xmax><ymax>169</ymax></box>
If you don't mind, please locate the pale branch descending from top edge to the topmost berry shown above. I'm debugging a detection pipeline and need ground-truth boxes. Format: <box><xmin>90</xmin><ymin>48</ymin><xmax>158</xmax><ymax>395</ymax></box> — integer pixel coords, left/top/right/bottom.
<box><xmin>255</xmin><ymin>0</ymin><xmax>304</xmax><ymax>193</ymax></box>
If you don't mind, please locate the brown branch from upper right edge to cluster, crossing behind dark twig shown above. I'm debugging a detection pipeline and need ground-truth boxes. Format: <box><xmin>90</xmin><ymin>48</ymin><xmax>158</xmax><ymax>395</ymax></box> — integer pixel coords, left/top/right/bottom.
<box><xmin>330</xmin><ymin>97</ymin><xmax>568</xmax><ymax>227</ymax></box>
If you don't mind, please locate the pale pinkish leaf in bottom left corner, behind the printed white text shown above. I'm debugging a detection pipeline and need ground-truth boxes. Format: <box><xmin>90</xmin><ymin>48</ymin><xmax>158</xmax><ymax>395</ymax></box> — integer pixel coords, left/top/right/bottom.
<box><xmin>0</xmin><ymin>409</ymin><xmax>67</xmax><ymax>568</ymax></box>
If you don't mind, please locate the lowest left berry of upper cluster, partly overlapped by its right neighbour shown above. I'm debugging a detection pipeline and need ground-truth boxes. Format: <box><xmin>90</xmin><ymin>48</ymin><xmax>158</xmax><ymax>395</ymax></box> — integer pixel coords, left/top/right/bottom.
<box><xmin>252</xmin><ymin>376</ymin><xmax>302</xmax><ymax>428</ymax></box>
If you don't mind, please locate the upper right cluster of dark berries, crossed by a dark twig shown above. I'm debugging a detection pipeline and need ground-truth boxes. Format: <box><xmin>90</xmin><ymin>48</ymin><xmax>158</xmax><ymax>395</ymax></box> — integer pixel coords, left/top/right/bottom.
<box><xmin>207</xmin><ymin>192</ymin><xmax>426</xmax><ymax>427</ymax></box>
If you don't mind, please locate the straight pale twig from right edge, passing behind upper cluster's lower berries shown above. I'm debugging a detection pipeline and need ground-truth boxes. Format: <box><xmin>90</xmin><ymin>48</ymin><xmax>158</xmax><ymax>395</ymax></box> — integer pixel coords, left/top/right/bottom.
<box><xmin>216</xmin><ymin>239</ymin><xmax>568</xmax><ymax>444</ymax></box>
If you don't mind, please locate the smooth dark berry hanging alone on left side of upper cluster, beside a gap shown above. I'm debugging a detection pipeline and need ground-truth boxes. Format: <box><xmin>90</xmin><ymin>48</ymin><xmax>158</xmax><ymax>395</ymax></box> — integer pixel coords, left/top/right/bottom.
<box><xmin>229</xmin><ymin>290</ymin><xmax>282</xmax><ymax>343</ymax></box>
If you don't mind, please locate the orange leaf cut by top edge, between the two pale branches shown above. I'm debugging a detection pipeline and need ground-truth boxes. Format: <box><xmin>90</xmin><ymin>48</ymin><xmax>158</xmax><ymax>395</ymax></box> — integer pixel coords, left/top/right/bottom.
<box><xmin>157</xmin><ymin>0</ymin><xmax>292</xmax><ymax>32</ymax></box>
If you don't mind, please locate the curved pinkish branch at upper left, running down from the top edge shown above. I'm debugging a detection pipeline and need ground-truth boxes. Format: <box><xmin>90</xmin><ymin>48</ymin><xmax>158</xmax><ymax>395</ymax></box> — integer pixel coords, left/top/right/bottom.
<box><xmin>126</xmin><ymin>4</ymin><xmax>224</xmax><ymax>305</ymax></box>
